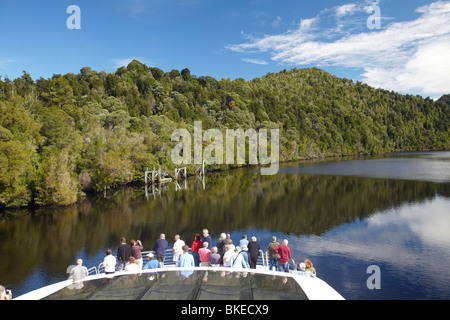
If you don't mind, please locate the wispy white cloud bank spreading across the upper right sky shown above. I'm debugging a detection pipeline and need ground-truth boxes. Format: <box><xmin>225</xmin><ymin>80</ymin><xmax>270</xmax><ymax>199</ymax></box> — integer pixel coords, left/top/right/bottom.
<box><xmin>227</xmin><ymin>1</ymin><xmax>450</xmax><ymax>96</ymax></box>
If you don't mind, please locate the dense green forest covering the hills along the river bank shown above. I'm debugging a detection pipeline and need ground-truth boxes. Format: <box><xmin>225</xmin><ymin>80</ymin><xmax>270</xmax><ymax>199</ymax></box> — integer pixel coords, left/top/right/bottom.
<box><xmin>0</xmin><ymin>60</ymin><xmax>450</xmax><ymax>207</ymax></box>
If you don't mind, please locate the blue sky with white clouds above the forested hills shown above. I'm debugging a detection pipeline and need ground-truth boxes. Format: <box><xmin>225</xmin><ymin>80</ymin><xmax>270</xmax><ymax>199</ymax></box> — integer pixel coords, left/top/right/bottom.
<box><xmin>0</xmin><ymin>0</ymin><xmax>450</xmax><ymax>98</ymax></box>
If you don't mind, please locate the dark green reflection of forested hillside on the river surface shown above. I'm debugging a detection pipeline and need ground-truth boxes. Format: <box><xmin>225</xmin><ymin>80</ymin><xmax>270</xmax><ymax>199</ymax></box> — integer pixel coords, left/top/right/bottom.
<box><xmin>0</xmin><ymin>162</ymin><xmax>450</xmax><ymax>300</ymax></box>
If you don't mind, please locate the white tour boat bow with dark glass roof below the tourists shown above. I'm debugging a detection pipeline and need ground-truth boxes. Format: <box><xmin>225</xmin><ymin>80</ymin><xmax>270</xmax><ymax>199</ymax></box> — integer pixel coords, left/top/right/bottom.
<box><xmin>14</xmin><ymin>249</ymin><xmax>344</xmax><ymax>301</ymax></box>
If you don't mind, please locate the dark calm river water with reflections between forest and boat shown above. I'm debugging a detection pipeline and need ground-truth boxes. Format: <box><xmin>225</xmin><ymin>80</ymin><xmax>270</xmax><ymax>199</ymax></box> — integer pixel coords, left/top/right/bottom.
<box><xmin>0</xmin><ymin>152</ymin><xmax>450</xmax><ymax>300</ymax></box>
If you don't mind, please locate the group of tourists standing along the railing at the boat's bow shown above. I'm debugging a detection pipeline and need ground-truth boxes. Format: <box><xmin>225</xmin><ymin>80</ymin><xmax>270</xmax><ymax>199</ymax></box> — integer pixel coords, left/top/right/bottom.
<box><xmin>69</xmin><ymin>229</ymin><xmax>316</xmax><ymax>280</ymax></box>
